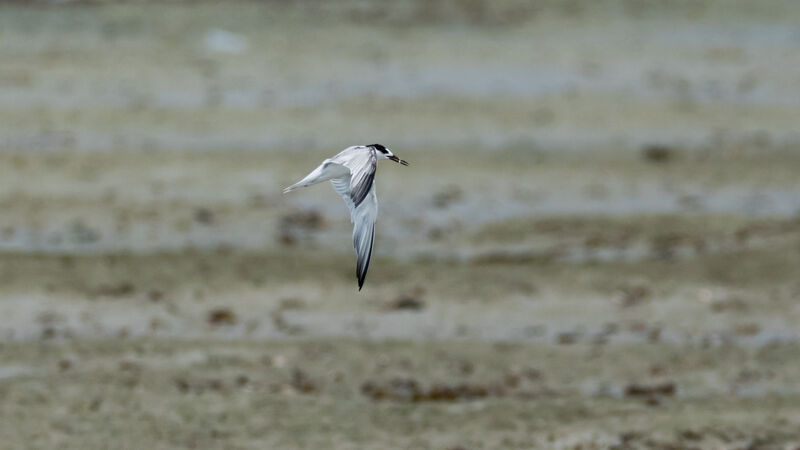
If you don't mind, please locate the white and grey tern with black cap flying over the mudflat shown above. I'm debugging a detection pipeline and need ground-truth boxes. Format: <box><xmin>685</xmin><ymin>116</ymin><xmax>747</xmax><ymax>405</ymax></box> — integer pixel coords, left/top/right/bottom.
<box><xmin>283</xmin><ymin>144</ymin><xmax>408</xmax><ymax>291</ymax></box>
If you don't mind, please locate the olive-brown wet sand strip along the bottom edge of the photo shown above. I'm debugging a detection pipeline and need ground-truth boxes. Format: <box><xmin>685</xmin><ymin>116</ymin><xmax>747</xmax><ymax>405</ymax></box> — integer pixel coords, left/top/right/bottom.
<box><xmin>0</xmin><ymin>338</ymin><xmax>800</xmax><ymax>448</ymax></box>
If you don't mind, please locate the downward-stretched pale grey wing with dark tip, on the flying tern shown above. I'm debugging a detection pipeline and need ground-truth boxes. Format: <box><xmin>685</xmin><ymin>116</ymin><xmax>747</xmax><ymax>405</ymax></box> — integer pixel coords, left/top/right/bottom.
<box><xmin>331</xmin><ymin>151</ymin><xmax>378</xmax><ymax>290</ymax></box>
